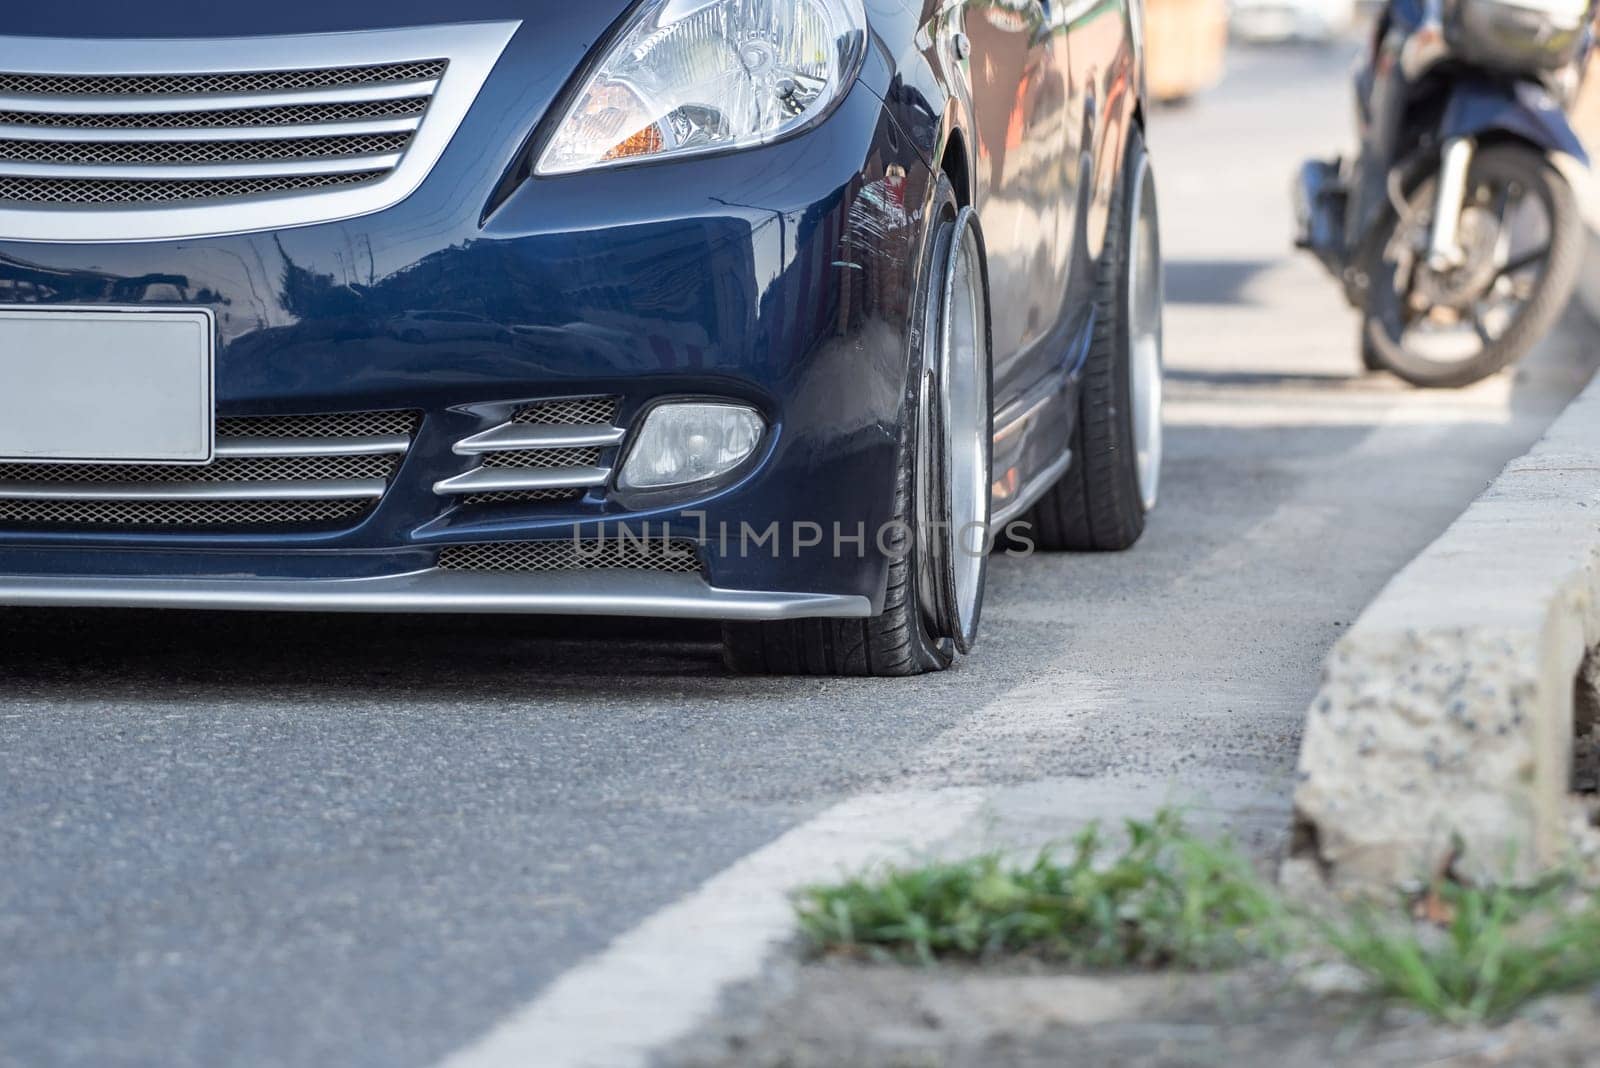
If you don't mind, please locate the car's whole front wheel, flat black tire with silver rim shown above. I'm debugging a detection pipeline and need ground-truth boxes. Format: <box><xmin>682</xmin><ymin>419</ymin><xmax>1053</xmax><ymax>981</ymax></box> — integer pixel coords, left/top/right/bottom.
<box><xmin>723</xmin><ymin>176</ymin><xmax>994</xmax><ymax>678</ymax></box>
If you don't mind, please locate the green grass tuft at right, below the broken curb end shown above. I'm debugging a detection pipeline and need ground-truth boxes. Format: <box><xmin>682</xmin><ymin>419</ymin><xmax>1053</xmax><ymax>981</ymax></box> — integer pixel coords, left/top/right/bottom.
<box><xmin>1325</xmin><ymin>884</ymin><xmax>1600</xmax><ymax>1023</ymax></box>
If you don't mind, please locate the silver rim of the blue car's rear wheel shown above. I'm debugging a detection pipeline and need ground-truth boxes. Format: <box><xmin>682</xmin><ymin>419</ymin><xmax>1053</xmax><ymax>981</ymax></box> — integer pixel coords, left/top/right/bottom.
<box><xmin>1128</xmin><ymin>160</ymin><xmax>1163</xmax><ymax>512</ymax></box>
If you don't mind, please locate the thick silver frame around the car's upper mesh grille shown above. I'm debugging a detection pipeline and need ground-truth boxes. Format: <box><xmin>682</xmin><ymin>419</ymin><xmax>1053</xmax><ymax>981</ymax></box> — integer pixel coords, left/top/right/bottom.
<box><xmin>0</xmin><ymin>21</ymin><xmax>522</xmax><ymax>243</ymax></box>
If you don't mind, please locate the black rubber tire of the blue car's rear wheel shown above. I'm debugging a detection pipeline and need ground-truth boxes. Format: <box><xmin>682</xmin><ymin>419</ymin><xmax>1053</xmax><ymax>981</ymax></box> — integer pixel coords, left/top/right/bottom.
<box><xmin>1026</xmin><ymin>128</ymin><xmax>1154</xmax><ymax>552</ymax></box>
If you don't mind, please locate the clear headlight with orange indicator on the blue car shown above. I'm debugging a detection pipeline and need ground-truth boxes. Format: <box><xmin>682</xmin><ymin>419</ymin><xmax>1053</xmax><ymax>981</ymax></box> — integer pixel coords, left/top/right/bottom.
<box><xmin>538</xmin><ymin>0</ymin><xmax>866</xmax><ymax>174</ymax></box>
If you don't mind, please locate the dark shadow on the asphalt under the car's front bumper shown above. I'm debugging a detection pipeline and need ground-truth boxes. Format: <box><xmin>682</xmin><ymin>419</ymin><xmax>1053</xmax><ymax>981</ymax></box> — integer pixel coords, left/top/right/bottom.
<box><xmin>0</xmin><ymin>609</ymin><xmax>722</xmax><ymax>697</ymax></box>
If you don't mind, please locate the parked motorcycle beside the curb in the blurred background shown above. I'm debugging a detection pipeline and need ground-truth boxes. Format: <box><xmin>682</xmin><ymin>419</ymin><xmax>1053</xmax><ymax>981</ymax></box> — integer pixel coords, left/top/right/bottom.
<box><xmin>1296</xmin><ymin>0</ymin><xmax>1592</xmax><ymax>387</ymax></box>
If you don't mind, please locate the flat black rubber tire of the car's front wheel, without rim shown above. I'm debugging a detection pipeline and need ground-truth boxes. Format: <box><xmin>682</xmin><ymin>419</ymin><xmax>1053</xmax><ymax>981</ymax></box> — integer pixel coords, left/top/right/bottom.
<box><xmin>723</xmin><ymin>174</ymin><xmax>982</xmax><ymax>678</ymax></box>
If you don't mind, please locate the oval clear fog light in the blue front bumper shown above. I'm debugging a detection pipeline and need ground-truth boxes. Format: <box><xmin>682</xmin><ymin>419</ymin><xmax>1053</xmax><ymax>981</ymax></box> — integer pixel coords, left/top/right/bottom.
<box><xmin>621</xmin><ymin>403</ymin><xmax>766</xmax><ymax>489</ymax></box>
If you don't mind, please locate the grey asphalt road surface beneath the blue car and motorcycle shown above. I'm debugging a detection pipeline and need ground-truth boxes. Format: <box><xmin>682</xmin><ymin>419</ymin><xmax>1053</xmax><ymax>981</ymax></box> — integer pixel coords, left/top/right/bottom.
<box><xmin>0</xmin><ymin>37</ymin><xmax>1587</xmax><ymax>1068</ymax></box>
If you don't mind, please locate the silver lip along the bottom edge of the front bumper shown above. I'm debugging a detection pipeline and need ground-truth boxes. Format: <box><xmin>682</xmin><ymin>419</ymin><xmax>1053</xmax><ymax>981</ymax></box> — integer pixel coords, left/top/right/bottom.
<box><xmin>0</xmin><ymin>569</ymin><xmax>872</xmax><ymax>620</ymax></box>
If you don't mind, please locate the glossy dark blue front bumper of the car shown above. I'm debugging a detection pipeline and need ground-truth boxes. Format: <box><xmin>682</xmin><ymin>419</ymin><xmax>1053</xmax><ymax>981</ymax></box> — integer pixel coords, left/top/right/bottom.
<box><xmin>0</xmin><ymin>85</ymin><xmax>930</xmax><ymax>619</ymax></box>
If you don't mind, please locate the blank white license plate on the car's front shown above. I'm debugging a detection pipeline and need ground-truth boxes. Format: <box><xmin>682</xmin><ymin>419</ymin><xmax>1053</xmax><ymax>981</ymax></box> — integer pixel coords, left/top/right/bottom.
<box><xmin>0</xmin><ymin>307</ymin><xmax>216</xmax><ymax>464</ymax></box>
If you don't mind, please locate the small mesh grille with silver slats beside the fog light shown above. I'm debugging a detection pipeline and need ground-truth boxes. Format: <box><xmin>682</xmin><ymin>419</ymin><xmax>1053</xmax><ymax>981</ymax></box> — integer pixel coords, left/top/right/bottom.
<box><xmin>434</xmin><ymin>397</ymin><xmax>624</xmax><ymax>504</ymax></box>
